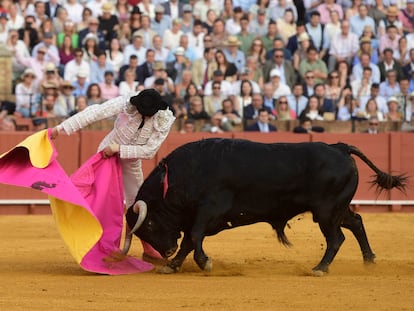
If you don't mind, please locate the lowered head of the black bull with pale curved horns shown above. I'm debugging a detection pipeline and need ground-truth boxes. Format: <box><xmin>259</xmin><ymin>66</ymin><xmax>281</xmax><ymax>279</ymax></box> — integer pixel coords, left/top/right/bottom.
<box><xmin>124</xmin><ymin>200</ymin><xmax>180</xmax><ymax>258</ymax></box>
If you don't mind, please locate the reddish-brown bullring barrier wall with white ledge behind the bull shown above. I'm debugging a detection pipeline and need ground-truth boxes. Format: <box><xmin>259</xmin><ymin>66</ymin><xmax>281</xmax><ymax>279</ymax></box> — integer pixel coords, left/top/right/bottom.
<box><xmin>0</xmin><ymin>131</ymin><xmax>414</xmax><ymax>214</ymax></box>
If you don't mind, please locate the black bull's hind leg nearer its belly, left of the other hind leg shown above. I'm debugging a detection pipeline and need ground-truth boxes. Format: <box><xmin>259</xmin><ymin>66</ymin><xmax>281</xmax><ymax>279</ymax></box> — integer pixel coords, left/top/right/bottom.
<box><xmin>312</xmin><ymin>220</ymin><xmax>345</xmax><ymax>276</ymax></box>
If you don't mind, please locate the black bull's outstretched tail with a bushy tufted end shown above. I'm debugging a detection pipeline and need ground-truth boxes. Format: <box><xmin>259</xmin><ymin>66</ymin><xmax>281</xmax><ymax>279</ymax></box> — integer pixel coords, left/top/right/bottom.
<box><xmin>348</xmin><ymin>146</ymin><xmax>408</xmax><ymax>193</ymax></box>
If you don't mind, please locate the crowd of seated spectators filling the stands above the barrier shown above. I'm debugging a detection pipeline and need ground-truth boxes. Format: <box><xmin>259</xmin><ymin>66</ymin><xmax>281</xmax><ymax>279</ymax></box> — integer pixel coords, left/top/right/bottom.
<box><xmin>0</xmin><ymin>0</ymin><xmax>414</xmax><ymax>132</ymax></box>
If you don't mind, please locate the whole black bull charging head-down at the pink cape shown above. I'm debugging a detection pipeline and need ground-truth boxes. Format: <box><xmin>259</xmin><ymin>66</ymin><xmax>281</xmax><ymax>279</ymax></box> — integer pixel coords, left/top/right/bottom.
<box><xmin>126</xmin><ymin>139</ymin><xmax>407</xmax><ymax>274</ymax></box>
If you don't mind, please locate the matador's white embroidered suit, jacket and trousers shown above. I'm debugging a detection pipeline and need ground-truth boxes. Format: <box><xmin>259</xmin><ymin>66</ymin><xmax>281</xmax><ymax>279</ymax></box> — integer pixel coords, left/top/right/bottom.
<box><xmin>58</xmin><ymin>96</ymin><xmax>175</xmax><ymax>208</ymax></box>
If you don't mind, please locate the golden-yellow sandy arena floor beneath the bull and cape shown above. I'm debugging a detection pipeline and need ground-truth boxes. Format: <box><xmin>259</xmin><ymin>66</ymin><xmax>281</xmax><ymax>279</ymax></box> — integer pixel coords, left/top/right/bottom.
<box><xmin>0</xmin><ymin>213</ymin><xmax>414</xmax><ymax>311</ymax></box>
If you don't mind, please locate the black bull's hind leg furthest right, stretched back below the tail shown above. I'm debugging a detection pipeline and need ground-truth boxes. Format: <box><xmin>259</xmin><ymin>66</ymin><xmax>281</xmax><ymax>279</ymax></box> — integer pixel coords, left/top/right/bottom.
<box><xmin>341</xmin><ymin>210</ymin><xmax>375</xmax><ymax>263</ymax></box>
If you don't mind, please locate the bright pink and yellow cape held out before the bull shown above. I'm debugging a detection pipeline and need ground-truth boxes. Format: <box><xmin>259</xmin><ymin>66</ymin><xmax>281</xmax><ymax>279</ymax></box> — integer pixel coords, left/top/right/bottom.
<box><xmin>0</xmin><ymin>130</ymin><xmax>153</xmax><ymax>275</ymax></box>
